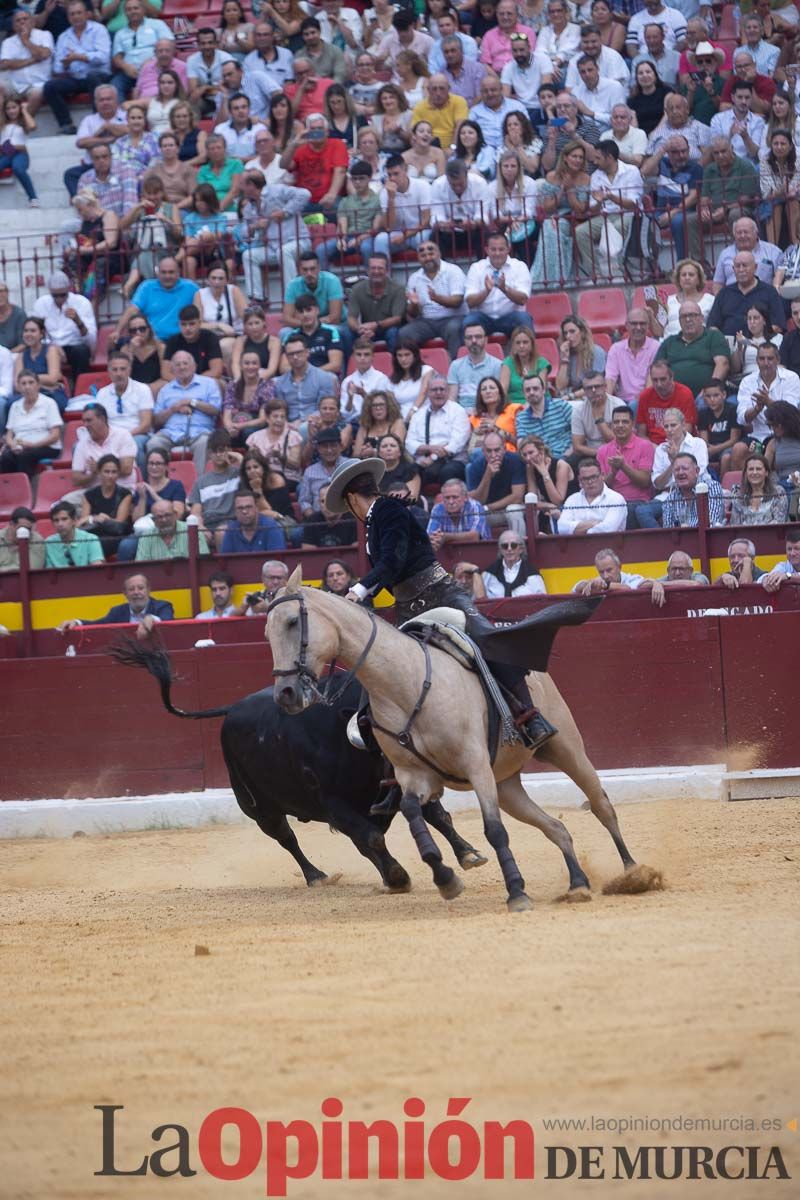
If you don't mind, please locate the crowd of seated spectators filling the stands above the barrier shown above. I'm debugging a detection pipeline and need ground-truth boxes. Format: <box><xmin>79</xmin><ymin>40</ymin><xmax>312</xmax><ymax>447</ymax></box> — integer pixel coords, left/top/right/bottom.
<box><xmin>0</xmin><ymin>0</ymin><xmax>800</xmax><ymax>612</ymax></box>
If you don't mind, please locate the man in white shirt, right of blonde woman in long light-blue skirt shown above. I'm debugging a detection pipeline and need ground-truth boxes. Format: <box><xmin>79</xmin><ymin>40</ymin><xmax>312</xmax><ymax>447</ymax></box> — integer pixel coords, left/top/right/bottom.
<box><xmin>575</xmin><ymin>138</ymin><xmax>644</xmax><ymax>281</ymax></box>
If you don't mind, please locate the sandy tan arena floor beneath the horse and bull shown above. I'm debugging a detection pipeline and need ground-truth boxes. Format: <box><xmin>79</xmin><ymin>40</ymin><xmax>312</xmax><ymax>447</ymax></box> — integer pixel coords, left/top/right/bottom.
<box><xmin>0</xmin><ymin>800</ymin><xmax>800</xmax><ymax>1200</ymax></box>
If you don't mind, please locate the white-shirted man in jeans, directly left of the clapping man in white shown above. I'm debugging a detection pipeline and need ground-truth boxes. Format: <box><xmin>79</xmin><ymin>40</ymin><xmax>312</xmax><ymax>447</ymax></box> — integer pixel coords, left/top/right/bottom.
<box><xmin>399</xmin><ymin>237</ymin><xmax>467</xmax><ymax>359</ymax></box>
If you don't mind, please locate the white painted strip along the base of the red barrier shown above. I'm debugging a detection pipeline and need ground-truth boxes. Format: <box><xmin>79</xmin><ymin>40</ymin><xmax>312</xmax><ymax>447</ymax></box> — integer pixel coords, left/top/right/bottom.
<box><xmin>0</xmin><ymin>763</ymin><xmax>734</xmax><ymax>838</ymax></box>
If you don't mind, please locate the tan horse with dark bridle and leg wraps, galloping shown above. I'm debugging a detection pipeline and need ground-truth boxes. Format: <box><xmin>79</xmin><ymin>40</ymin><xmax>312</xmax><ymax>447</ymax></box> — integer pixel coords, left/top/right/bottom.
<box><xmin>265</xmin><ymin>566</ymin><xmax>662</xmax><ymax>912</ymax></box>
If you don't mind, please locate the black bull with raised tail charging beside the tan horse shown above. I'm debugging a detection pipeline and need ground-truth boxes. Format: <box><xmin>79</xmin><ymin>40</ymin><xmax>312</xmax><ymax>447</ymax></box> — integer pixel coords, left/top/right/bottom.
<box><xmin>109</xmin><ymin>637</ymin><xmax>486</xmax><ymax>892</ymax></box>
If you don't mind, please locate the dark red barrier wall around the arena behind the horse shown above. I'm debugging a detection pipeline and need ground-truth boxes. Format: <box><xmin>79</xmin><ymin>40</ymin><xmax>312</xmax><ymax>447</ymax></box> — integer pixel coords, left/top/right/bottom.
<box><xmin>0</xmin><ymin>587</ymin><xmax>800</xmax><ymax>799</ymax></box>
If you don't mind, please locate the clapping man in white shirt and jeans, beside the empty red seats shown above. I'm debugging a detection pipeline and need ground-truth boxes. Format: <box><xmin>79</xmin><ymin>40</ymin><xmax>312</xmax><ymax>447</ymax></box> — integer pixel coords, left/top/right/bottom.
<box><xmin>463</xmin><ymin>233</ymin><xmax>534</xmax><ymax>335</ymax></box>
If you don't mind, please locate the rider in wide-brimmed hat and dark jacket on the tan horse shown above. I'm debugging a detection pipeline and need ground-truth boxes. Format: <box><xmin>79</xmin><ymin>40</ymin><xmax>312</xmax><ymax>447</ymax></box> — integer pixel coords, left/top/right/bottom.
<box><xmin>325</xmin><ymin>458</ymin><xmax>557</xmax><ymax>811</ymax></box>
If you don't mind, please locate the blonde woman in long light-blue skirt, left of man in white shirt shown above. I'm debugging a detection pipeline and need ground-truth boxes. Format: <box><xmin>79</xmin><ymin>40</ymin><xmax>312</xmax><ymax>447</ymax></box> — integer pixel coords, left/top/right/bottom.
<box><xmin>530</xmin><ymin>142</ymin><xmax>590</xmax><ymax>288</ymax></box>
